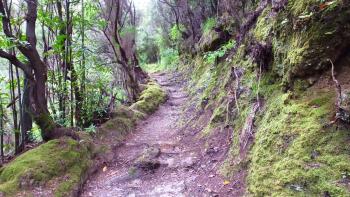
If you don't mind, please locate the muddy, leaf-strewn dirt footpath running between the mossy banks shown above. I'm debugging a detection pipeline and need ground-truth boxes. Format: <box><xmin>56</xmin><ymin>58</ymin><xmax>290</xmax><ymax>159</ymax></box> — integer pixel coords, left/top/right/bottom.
<box><xmin>81</xmin><ymin>74</ymin><xmax>244</xmax><ymax>197</ymax></box>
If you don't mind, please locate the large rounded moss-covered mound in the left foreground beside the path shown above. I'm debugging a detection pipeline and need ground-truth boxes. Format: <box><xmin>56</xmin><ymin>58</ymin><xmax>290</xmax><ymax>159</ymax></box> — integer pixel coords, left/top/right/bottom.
<box><xmin>0</xmin><ymin>138</ymin><xmax>91</xmax><ymax>196</ymax></box>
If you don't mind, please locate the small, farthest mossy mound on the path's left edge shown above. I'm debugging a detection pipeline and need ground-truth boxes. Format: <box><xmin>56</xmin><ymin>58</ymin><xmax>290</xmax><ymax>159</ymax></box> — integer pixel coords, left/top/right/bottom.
<box><xmin>130</xmin><ymin>82</ymin><xmax>167</xmax><ymax>115</ymax></box>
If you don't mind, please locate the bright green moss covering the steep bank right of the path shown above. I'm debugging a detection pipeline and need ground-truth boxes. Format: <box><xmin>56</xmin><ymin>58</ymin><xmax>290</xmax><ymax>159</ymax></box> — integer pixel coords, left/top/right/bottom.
<box><xmin>175</xmin><ymin>0</ymin><xmax>350</xmax><ymax>196</ymax></box>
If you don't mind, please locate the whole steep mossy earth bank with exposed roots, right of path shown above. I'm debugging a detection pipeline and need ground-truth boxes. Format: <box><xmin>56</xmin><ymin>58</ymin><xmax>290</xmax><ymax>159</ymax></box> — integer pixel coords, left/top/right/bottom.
<box><xmin>179</xmin><ymin>0</ymin><xmax>350</xmax><ymax>196</ymax></box>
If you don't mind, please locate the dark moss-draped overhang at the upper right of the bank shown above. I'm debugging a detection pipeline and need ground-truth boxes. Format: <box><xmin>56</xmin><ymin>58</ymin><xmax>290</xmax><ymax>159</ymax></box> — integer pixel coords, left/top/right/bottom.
<box><xmin>272</xmin><ymin>0</ymin><xmax>350</xmax><ymax>84</ymax></box>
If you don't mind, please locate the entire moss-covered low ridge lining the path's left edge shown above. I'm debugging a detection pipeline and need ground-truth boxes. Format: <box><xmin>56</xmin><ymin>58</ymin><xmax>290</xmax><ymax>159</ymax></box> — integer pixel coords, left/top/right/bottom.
<box><xmin>0</xmin><ymin>79</ymin><xmax>166</xmax><ymax>196</ymax></box>
